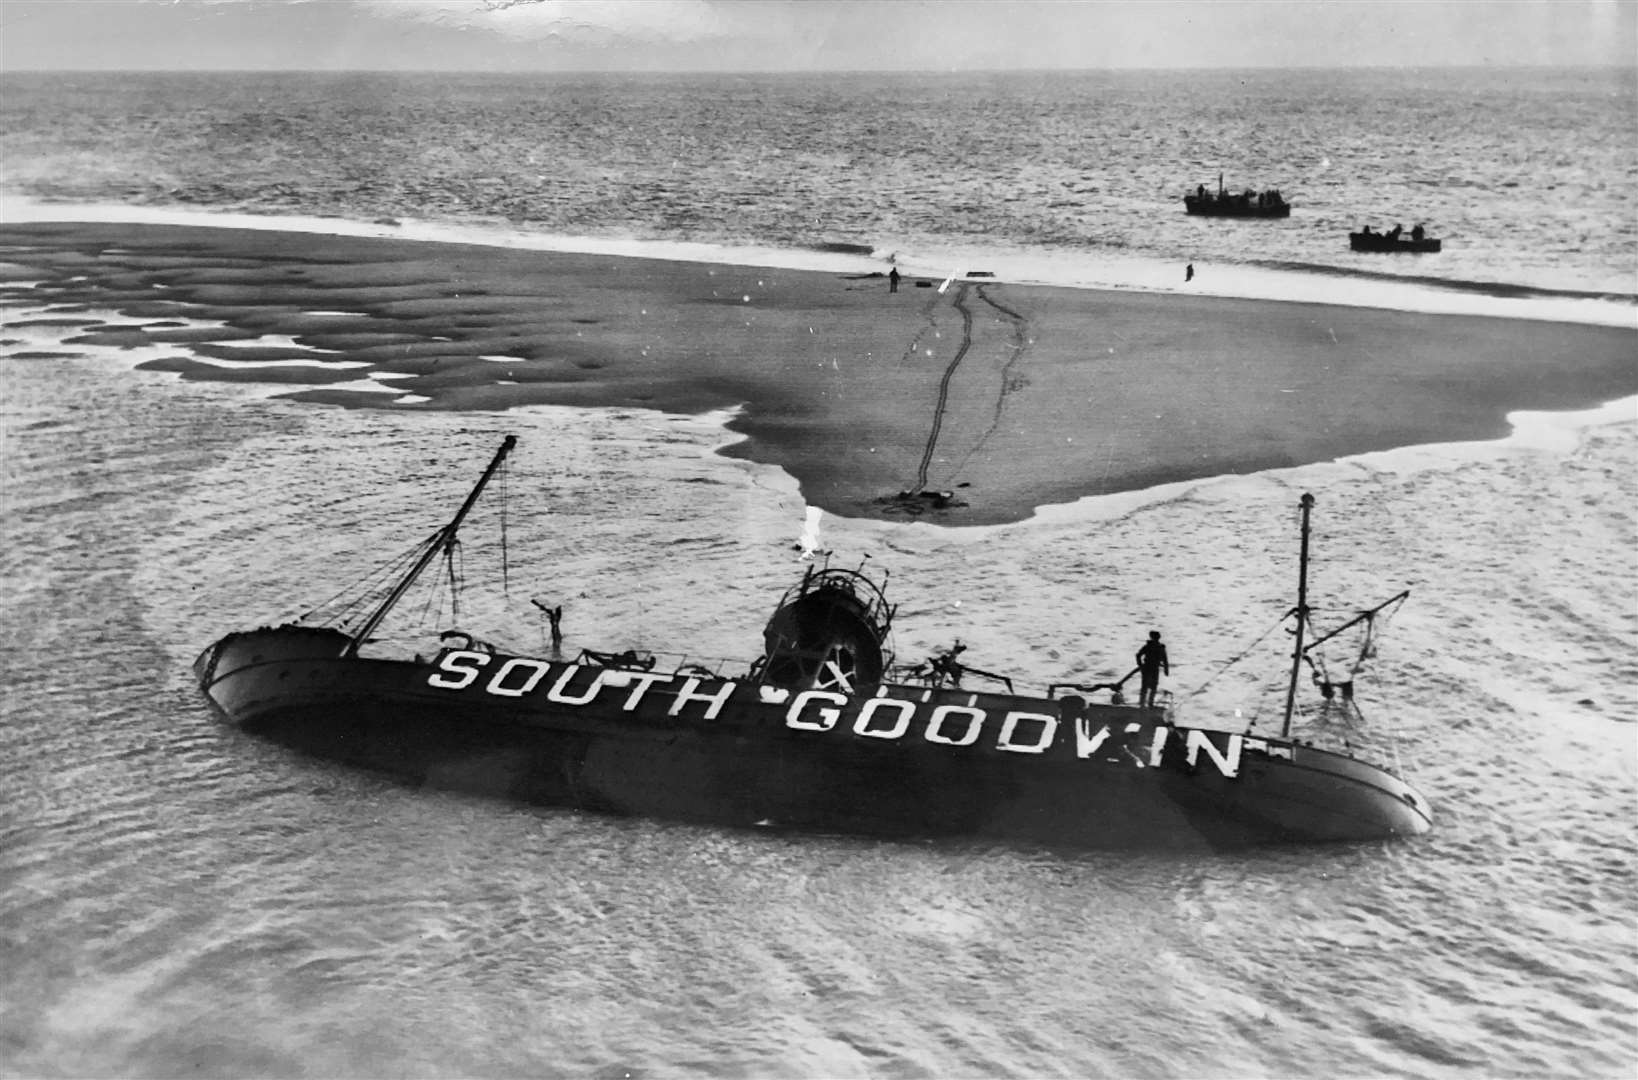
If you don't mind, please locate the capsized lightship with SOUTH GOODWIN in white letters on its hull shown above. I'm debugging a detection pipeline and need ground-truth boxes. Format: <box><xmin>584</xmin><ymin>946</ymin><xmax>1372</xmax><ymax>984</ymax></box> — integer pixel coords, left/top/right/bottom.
<box><xmin>195</xmin><ymin>436</ymin><xmax>1430</xmax><ymax>849</ymax></box>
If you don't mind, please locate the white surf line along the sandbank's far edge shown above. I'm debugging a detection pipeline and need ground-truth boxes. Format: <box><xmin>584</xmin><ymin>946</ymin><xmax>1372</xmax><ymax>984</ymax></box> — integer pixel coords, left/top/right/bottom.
<box><xmin>0</xmin><ymin>195</ymin><xmax>1638</xmax><ymax>329</ymax></box>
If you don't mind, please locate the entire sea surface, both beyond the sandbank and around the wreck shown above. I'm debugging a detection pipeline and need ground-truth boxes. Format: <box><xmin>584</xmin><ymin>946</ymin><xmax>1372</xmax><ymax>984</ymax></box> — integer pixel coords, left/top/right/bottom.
<box><xmin>0</xmin><ymin>72</ymin><xmax>1638</xmax><ymax>1080</ymax></box>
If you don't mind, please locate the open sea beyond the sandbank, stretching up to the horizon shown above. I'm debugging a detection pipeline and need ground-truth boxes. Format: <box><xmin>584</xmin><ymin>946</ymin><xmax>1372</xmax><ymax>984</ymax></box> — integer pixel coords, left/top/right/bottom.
<box><xmin>0</xmin><ymin>69</ymin><xmax>1638</xmax><ymax>302</ymax></box>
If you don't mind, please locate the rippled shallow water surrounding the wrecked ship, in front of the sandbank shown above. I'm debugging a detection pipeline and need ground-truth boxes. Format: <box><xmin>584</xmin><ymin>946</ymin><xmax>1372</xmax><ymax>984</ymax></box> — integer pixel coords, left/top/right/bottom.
<box><xmin>0</xmin><ymin>316</ymin><xmax>1638</xmax><ymax>1077</ymax></box>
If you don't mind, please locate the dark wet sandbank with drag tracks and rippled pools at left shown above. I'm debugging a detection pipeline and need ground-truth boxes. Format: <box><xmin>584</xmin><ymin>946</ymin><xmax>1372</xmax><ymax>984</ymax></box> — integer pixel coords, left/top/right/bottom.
<box><xmin>0</xmin><ymin>223</ymin><xmax>1638</xmax><ymax>524</ymax></box>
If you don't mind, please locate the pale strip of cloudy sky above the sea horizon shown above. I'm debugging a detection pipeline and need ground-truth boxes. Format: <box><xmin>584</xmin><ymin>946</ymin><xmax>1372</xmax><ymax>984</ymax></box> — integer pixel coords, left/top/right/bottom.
<box><xmin>0</xmin><ymin>0</ymin><xmax>1638</xmax><ymax>72</ymax></box>
